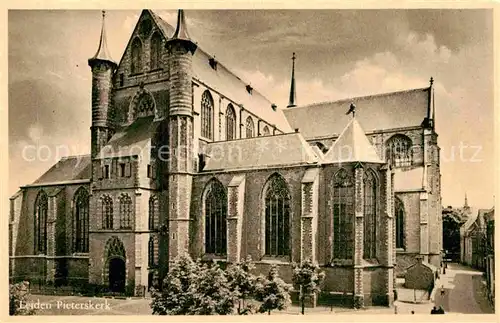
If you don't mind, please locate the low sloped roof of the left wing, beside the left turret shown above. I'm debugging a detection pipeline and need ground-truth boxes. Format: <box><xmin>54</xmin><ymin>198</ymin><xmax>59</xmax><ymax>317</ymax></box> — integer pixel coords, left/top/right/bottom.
<box><xmin>32</xmin><ymin>155</ymin><xmax>90</xmax><ymax>185</ymax></box>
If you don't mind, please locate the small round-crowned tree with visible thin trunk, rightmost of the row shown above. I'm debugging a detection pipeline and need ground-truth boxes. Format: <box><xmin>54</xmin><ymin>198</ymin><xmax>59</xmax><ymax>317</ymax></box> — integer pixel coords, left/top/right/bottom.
<box><xmin>292</xmin><ymin>260</ymin><xmax>325</xmax><ymax>315</ymax></box>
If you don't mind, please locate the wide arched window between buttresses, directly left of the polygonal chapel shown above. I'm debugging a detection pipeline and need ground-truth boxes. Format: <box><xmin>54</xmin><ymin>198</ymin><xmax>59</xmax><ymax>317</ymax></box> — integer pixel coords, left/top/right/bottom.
<box><xmin>264</xmin><ymin>174</ymin><xmax>290</xmax><ymax>256</ymax></box>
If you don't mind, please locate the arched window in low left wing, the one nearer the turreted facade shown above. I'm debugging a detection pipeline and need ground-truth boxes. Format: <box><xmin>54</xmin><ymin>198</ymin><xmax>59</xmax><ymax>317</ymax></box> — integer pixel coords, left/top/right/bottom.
<box><xmin>73</xmin><ymin>188</ymin><xmax>89</xmax><ymax>252</ymax></box>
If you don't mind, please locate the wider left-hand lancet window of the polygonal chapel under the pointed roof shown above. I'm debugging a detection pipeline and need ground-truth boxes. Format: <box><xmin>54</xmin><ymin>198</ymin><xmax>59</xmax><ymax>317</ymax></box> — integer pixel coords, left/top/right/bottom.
<box><xmin>332</xmin><ymin>168</ymin><xmax>354</xmax><ymax>259</ymax></box>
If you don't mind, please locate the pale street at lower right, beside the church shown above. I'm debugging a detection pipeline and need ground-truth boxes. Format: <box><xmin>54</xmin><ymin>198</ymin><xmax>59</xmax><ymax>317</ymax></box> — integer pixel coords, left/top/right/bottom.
<box><xmin>435</xmin><ymin>263</ymin><xmax>494</xmax><ymax>314</ymax></box>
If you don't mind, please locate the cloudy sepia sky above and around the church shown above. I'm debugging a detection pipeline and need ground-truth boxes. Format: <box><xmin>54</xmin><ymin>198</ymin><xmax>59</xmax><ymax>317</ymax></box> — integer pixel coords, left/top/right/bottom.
<box><xmin>8</xmin><ymin>9</ymin><xmax>495</xmax><ymax>208</ymax></box>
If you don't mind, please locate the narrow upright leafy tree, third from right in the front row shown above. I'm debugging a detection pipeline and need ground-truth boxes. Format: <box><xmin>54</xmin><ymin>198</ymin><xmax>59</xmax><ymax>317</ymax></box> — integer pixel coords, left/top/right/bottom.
<box><xmin>226</xmin><ymin>256</ymin><xmax>257</xmax><ymax>315</ymax></box>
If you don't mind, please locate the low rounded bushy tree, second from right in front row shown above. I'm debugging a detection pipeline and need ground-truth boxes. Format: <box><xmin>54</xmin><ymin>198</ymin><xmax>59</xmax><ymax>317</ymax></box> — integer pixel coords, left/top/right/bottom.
<box><xmin>255</xmin><ymin>265</ymin><xmax>292</xmax><ymax>315</ymax></box>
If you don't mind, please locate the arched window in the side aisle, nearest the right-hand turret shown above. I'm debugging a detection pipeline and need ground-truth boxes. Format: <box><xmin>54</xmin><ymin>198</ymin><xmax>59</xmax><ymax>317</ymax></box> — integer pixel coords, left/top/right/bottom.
<box><xmin>204</xmin><ymin>180</ymin><xmax>227</xmax><ymax>255</ymax></box>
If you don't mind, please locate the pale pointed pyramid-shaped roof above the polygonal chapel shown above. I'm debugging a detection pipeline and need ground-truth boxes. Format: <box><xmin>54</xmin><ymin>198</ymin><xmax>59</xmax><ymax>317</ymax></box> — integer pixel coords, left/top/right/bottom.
<box><xmin>323</xmin><ymin>118</ymin><xmax>385</xmax><ymax>164</ymax></box>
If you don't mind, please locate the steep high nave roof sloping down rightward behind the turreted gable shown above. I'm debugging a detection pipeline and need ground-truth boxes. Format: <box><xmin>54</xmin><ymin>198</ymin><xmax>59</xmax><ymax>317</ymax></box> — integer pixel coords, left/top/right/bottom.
<box><xmin>149</xmin><ymin>10</ymin><xmax>292</xmax><ymax>133</ymax></box>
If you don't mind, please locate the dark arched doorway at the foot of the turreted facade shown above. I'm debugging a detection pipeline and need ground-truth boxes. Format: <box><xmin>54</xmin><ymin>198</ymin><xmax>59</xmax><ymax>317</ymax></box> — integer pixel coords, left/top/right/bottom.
<box><xmin>103</xmin><ymin>236</ymin><xmax>127</xmax><ymax>293</ymax></box>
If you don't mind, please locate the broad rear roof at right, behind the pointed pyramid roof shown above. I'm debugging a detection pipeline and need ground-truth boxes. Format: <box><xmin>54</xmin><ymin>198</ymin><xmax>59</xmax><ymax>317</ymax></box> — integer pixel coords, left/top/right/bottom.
<box><xmin>284</xmin><ymin>87</ymin><xmax>429</xmax><ymax>139</ymax></box>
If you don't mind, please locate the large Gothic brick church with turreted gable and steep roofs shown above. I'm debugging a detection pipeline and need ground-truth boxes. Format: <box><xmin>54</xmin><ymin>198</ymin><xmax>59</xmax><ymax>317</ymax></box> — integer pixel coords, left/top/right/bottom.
<box><xmin>9</xmin><ymin>10</ymin><xmax>442</xmax><ymax>307</ymax></box>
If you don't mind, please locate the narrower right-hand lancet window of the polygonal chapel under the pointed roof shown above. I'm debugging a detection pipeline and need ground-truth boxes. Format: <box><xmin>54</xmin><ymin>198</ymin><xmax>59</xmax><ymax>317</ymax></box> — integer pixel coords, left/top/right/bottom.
<box><xmin>363</xmin><ymin>169</ymin><xmax>378</xmax><ymax>259</ymax></box>
